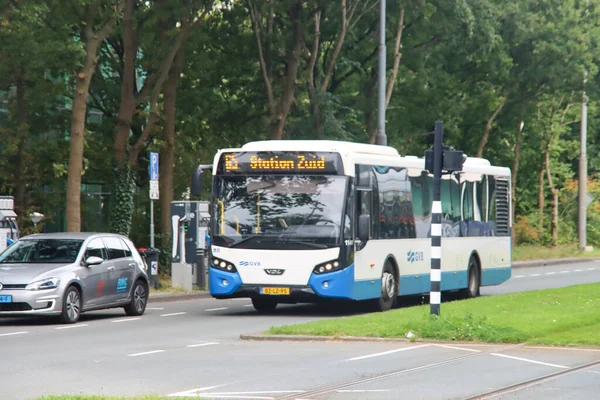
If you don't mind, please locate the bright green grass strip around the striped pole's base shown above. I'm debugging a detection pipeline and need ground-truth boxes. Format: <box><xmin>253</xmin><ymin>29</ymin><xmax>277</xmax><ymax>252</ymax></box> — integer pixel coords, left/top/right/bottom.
<box><xmin>266</xmin><ymin>283</ymin><xmax>600</xmax><ymax>346</ymax></box>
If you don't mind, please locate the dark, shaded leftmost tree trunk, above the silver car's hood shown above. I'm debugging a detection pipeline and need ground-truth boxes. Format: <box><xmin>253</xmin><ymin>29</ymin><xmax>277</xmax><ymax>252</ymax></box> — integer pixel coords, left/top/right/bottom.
<box><xmin>15</xmin><ymin>69</ymin><xmax>29</xmax><ymax>223</ymax></box>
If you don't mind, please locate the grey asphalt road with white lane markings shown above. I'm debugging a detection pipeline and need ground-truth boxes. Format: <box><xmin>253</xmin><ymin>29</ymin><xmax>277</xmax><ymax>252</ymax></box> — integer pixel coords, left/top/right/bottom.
<box><xmin>0</xmin><ymin>262</ymin><xmax>600</xmax><ymax>400</ymax></box>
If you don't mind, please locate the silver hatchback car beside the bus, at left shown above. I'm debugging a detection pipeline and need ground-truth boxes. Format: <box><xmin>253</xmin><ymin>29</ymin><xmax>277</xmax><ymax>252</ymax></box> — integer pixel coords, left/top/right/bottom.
<box><xmin>0</xmin><ymin>233</ymin><xmax>149</xmax><ymax>324</ymax></box>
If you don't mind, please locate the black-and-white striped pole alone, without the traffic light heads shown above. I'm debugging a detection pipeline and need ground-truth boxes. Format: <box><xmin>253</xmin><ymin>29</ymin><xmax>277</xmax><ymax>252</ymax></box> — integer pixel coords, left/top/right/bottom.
<box><xmin>429</xmin><ymin>121</ymin><xmax>443</xmax><ymax>315</ymax></box>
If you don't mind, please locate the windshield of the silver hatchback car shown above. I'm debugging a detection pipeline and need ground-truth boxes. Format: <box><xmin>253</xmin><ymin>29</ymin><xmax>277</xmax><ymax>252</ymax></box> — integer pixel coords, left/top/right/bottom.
<box><xmin>0</xmin><ymin>239</ymin><xmax>83</xmax><ymax>264</ymax></box>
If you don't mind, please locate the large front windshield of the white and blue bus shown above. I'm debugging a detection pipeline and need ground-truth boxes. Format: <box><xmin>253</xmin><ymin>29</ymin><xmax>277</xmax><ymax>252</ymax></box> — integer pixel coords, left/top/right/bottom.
<box><xmin>212</xmin><ymin>175</ymin><xmax>350</xmax><ymax>249</ymax></box>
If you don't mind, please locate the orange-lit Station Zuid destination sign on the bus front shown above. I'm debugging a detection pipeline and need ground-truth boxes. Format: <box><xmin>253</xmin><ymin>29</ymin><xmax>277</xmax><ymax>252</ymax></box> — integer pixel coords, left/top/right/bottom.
<box><xmin>219</xmin><ymin>151</ymin><xmax>342</xmax><ymax>175</ymax></box>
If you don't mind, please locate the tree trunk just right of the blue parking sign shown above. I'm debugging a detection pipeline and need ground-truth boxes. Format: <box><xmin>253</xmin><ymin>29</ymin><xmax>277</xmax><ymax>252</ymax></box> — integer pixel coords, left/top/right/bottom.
<box><xmin>159</xmin><ymin>48</ymin><xmax>184</xmax><ymax>271</ymax></box>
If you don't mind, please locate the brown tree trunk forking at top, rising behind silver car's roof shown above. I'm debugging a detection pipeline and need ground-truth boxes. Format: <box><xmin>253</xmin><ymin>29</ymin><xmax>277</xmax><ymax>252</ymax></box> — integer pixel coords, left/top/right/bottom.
<box><xmin>67</xmin><ymin>5</ymin><xmax>117</xmax><ymax>232</ymax></box>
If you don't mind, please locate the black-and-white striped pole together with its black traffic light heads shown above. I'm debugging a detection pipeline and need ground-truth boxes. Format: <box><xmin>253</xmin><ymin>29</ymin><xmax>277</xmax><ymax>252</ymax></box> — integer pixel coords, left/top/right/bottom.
<box><xmin>425</xmin><ymin>121</ymin><xmax>466</xmax><ymax>315</ymax></box>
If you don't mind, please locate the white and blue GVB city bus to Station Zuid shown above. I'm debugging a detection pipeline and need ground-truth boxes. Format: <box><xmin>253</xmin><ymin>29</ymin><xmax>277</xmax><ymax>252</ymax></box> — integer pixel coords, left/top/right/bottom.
<box><xmin>192</xmin><ymin>140</ymin><xmax>512</xmax><ymax>312</ymax></box>
